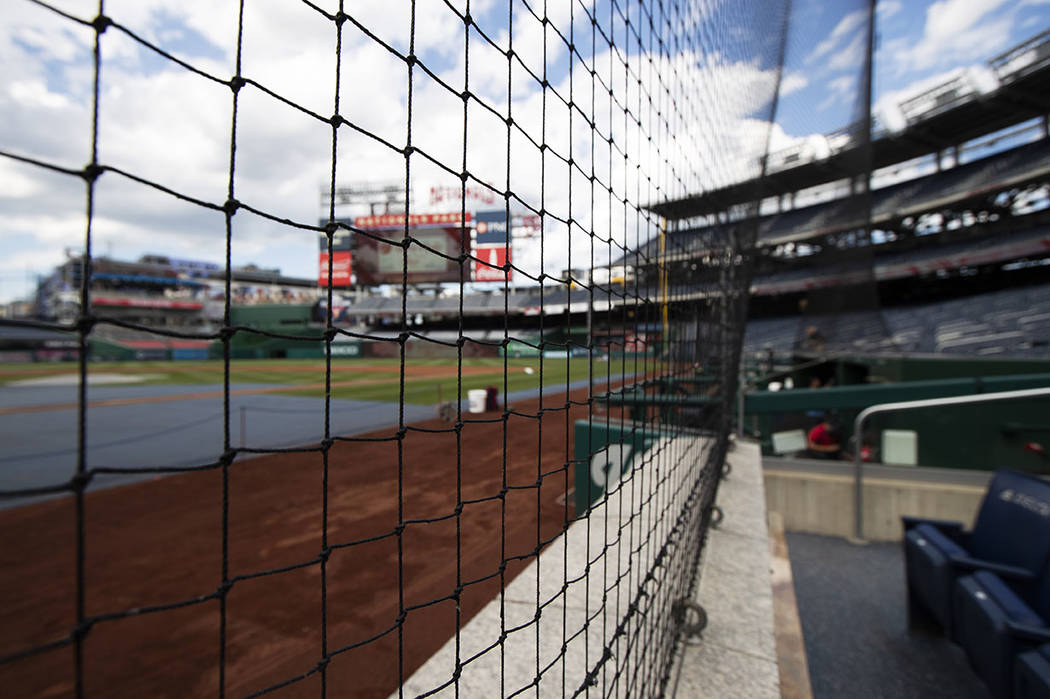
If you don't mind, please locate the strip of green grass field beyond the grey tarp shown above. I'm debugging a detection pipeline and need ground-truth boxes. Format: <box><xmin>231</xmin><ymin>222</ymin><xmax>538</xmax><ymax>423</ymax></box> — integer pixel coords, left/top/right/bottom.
<box><xmin>0</xmin><ymin>358</ymin><xmax>642</xmax><ymax>405</ymax></box>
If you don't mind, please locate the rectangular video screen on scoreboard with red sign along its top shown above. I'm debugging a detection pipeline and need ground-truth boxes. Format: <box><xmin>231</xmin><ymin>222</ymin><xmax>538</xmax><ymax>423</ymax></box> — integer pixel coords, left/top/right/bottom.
<box><xmin>354</xmin><ymin>214</ymin><xmax>469</xmax><ymax>285</ymax></box>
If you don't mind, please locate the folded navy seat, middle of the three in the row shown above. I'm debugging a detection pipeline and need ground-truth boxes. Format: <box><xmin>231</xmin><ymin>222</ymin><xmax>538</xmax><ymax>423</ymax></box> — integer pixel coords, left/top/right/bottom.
<box><xmin>952</xmin><ymin>570</ymin><xmax>1050</xmax><ymax>699</ymax></box>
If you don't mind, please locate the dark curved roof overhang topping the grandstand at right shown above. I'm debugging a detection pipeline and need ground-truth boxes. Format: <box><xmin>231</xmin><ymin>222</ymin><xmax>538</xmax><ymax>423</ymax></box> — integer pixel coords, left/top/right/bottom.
<box><xmin>649</xmin><ymin>33</ymin><xmax>1050</xmax><ymax>220</ymax></box>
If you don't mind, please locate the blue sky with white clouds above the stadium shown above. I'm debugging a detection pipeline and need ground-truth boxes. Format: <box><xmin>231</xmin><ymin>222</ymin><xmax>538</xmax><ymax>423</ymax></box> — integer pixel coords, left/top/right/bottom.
<box><xmin>0</xmin><ymin>0</ymin><xmax>1050</xmax><ymax>302</ymax></box>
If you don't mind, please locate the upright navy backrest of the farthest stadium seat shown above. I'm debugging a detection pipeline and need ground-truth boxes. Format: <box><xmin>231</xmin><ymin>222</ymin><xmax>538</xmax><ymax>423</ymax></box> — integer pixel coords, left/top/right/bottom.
<box><xmin>970</xmin><ymin>470</ymin><xmax>1050</xmax><ymax>571</ymax></box>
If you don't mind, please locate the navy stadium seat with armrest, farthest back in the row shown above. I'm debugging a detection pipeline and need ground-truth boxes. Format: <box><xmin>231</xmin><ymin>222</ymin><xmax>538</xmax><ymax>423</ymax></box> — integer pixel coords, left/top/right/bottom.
<box><xmin>902</xmin><ymin>470</ymin><xmax>1050</xmax><ymax>638</ymax></box>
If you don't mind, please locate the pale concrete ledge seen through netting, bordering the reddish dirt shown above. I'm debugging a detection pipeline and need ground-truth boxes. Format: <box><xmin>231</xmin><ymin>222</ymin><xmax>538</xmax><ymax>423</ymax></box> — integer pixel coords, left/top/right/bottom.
<box><xmin>393</xmin><ymin>437</ymin><xmax>713</xmax><ymax>699</ymax></box>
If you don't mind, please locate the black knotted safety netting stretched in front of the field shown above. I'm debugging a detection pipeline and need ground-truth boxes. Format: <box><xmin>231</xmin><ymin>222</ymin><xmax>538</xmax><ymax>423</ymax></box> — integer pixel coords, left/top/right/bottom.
<box><xmin>0</xmin><ymin>0</ymin><xmax>789</xmax><ymax>697</ymax></box>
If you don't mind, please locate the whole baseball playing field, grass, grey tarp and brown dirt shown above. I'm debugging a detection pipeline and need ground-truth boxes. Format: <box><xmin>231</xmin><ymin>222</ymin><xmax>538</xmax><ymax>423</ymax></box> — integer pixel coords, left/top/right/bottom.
<box><xmin>0</xmin><ymin>359</ymin><xmax>645</xmax><ymax>697</ymax></box>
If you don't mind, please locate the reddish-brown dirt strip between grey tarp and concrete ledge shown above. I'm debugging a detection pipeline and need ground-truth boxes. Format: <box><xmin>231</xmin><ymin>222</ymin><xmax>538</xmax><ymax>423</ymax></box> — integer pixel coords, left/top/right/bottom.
<box><xmin>0</xmin><ymin>389</ymin><xmax>625</xmax><ymax>697</ymax></box>
